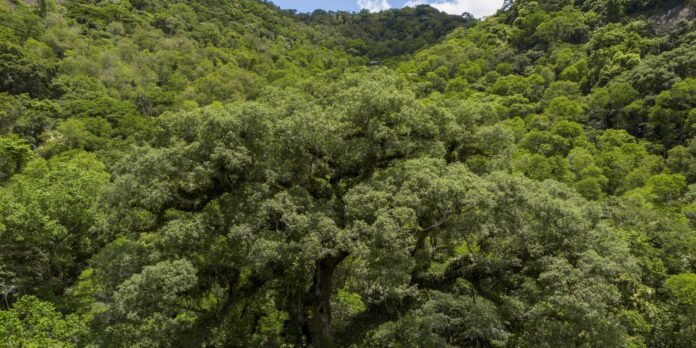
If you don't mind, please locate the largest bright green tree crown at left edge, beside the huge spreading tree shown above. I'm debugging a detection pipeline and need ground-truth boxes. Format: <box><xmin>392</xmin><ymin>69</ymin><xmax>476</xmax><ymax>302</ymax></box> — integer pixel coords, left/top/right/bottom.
<box><xmin>0</xmin><ymin>153</ymin><xmax>109</xmax><ymax>298</ymax></box>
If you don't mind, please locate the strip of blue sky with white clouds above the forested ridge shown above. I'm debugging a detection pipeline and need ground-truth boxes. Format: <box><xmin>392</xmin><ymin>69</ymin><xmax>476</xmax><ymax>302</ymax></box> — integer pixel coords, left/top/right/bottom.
<box><xmin>272</xmin><ymin>0</ymin><xmax>503</xmax><ymax>17</ymax></box>
